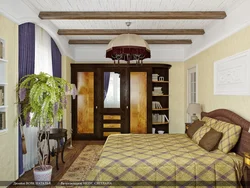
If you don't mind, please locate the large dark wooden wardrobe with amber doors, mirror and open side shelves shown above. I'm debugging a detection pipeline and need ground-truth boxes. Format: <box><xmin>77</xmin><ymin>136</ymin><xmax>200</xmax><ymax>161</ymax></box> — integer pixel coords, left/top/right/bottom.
<box><xmin>71</xmin><ymin>64</ymin><xmax>171</xmax><ymax>140</ymax></box>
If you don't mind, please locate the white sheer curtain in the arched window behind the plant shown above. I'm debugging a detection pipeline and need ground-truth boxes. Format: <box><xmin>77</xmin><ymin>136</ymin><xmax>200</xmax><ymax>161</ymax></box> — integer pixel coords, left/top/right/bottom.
<box><xmin>23</xmin><ymin>25</ymin><xmax>57</xmax><ymax>171</ymax></box>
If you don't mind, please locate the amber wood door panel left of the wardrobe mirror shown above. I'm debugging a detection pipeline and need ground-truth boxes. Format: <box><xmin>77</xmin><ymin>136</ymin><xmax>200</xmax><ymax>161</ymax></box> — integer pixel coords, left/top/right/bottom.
<box><xmin>77</xmin><ymin>72</ymin><xmax>94</xmax><ymax>134</ymax></box>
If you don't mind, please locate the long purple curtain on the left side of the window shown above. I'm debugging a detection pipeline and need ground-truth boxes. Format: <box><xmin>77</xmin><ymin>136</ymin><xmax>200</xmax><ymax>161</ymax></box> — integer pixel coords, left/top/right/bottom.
<box><xmin>18</xmin><ymin>23</ymin><xmax>35</xmax><ymax>176</ymax></box>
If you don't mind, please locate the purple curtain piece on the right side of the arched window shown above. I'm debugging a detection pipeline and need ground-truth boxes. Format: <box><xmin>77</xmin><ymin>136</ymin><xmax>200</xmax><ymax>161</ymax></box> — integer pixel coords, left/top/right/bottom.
<box><xmin>51</xmin><ymin>38</ymin><xmax>62</xmax><ymax>78</ymax></box>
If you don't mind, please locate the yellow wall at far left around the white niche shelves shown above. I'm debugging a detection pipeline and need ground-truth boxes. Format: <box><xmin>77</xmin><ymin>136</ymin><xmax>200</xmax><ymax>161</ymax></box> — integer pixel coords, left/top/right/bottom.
<box><xmin>0</xmin><ymin>15</ymin><xmax>18</xmax><ymax>181</ymax></box>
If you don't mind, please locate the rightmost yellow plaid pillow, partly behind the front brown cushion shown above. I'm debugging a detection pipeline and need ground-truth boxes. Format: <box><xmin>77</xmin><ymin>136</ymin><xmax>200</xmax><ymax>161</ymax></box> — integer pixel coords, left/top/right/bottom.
<box><xmin>212</xmin><ymin>120</ymin><xmax>241</xmax><ymax>153</ymax></box>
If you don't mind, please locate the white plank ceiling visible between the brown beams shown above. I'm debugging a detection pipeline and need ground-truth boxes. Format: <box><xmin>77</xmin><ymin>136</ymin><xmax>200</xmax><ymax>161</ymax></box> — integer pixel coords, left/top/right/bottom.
<box><xmin>23</xmin><ymin>0</ymin><xmax>245</xmax><ymax>40</ymax></box>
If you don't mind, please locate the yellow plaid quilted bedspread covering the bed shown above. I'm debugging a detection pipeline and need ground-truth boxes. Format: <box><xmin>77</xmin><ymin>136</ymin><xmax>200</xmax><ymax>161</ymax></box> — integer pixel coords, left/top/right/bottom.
<box><xmin>86</xmin><ymin>134</ymin><xmax>243</xmax><ymax>187</ymax></box>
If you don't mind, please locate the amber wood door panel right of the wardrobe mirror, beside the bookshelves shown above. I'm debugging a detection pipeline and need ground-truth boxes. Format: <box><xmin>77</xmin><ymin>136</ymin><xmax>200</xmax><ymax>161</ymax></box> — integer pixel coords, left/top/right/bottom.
<box><xmin>130</xmin><ymin>72</ymin><xmax>147</xmax><ymax>133</ymax></box>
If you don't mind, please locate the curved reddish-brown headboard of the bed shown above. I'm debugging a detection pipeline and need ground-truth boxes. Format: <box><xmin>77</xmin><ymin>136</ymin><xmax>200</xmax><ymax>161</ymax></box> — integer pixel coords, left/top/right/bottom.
<box><xmin>201</xmin><ymin>109</ymin><xmax>250</xmax><ymax>156</ymax></box>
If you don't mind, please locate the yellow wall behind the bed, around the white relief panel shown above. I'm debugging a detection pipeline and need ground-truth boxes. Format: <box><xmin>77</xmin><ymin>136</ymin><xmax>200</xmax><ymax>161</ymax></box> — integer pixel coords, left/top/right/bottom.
<box><xmin>184</xmin><ymin>27</ymin><xmax>250</xmax><ymax>120</ymax></box>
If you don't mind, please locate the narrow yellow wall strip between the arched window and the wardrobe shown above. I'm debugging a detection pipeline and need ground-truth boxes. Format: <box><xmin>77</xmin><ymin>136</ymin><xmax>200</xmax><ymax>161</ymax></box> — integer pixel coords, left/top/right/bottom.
<box><xmin>62</xmin><ymin>56</ymin><xmax>74</xmax><ymax>138</ymax></box>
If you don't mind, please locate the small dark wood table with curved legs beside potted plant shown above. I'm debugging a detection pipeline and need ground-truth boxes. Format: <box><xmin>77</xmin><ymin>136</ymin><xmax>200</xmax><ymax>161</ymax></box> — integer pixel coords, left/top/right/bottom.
<box><xmin>48</xmin><ymin>128</ymin><xmax>67</xmax><ymax>170</ymax></box>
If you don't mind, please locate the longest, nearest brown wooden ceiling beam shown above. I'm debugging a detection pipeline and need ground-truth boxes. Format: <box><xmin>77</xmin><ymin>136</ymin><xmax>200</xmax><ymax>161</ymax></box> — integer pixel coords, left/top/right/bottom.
<box><xmin>39</xmin><ymin>11</ymin><xmax>227</xmax><ymax>20</ymax></box>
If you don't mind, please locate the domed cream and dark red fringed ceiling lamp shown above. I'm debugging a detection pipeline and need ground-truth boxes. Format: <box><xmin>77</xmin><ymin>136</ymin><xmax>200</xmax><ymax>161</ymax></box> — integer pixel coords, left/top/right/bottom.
<box><xmin>106</xmin><ymin>22</ymin><xmax>151</xmax><ymax>65</ymax></box>
